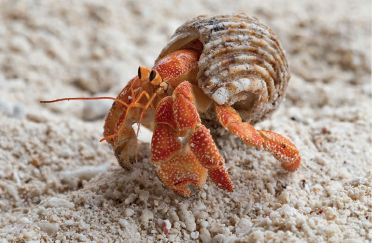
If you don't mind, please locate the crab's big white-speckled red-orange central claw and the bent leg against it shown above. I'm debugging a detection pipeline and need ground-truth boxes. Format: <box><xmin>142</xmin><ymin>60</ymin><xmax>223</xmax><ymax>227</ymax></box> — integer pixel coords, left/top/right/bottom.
<box><xmin>151</xmin><ymin>82</ymin><xmax>233</xmax><ymax>197</ymax></box>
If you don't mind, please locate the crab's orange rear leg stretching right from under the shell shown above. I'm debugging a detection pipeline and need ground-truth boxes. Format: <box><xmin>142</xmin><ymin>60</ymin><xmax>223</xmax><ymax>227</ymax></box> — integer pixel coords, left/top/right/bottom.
<box><xmin>215</xmin><ymin>103</ymin><xmax>301</xmax><ymax>171</ymax></box>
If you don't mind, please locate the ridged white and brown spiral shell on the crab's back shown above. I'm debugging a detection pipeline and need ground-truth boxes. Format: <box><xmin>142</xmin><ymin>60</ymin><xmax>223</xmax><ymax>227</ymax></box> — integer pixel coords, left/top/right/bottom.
<box><xmin>156</xmin><ymin>14</ymin><xmax>290</xmax><ymax>124</ymax></box>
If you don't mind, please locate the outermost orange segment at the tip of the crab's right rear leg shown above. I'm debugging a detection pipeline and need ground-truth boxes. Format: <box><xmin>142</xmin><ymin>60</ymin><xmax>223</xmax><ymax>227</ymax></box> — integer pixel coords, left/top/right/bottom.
<box><xmin>258</xmin><ymin>131</ymin><xmax>301</xmax><ymax>171</ymax></box>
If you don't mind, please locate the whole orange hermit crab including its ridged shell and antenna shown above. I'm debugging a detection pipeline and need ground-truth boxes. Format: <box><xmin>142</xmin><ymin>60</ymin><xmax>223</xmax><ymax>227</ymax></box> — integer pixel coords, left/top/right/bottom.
<box><xmin>42</xmin><ymin>14</ymin><xmax>301</xmax><ymax>197</ymax></box>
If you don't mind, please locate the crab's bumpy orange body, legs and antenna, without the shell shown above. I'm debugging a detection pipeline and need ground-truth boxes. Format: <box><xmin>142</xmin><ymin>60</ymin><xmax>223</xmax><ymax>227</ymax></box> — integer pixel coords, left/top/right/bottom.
<box><xmin>43</xmin><ymin>13</ymin><xmax>301</xmax><ymax>197</ymax></box>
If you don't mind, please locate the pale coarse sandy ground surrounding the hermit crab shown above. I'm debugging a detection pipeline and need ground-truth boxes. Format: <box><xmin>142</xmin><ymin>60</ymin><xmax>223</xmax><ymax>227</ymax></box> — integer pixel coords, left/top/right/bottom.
<box><xmin>0</xmin><ymin>0</ymin><xmax>372</xmax><ymax>242</ymax></box>
